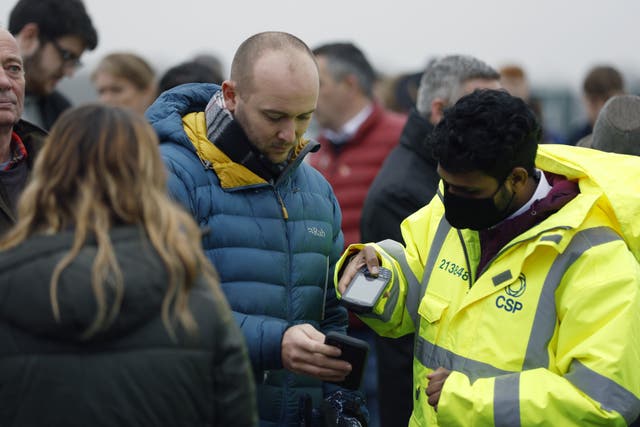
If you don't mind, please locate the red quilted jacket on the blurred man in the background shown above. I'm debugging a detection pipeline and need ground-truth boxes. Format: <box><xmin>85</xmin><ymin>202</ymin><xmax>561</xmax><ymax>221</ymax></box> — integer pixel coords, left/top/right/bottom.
<box><xmin>310</xmin><ymin>103</ymin><xmax>407</xmax><ymax>247</ymax></box>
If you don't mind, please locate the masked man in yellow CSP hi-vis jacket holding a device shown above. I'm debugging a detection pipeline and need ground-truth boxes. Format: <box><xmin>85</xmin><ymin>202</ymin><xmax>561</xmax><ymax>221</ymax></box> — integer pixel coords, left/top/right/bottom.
<box><xmin>335</xmin><ymin>90</ymin><xmax>640</xmax><ymax>427</ymax></box>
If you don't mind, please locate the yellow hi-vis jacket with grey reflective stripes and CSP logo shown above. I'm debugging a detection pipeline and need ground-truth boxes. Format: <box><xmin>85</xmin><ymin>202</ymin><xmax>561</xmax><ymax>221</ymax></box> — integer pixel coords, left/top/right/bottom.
<box><xmin>335</xmin><ymin>145</ymin><xmax>640</xmax><ymax>427</ymax></box>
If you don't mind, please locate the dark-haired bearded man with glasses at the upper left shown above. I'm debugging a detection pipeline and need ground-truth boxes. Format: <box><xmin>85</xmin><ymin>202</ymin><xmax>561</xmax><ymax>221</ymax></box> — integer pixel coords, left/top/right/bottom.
<box><xmin>9</xmin><ymin>0</ymin><xmax>98</xmax><ymax>129</ymax></box>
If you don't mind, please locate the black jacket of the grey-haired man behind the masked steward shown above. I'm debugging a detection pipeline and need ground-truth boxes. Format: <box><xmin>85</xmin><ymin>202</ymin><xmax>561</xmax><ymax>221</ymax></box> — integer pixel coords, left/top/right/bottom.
<box><xmin>360</xmin><ymin>109</ymin><xmax>440</xmax><ymax>242</ymax></box>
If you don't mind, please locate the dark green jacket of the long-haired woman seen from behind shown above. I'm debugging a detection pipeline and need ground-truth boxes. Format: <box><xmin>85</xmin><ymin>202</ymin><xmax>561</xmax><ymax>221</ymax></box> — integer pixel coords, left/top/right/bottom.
<box><xmin>0</xmin><ymin>227</ymin><xmax>257</xmax><ymax>427</ymax></box>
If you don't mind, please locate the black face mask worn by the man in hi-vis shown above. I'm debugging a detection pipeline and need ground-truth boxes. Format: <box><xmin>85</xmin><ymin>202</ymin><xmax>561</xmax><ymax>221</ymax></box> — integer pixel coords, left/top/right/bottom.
<box><xmin>443</xmin><ymin>180</ymin><xmax>516</xmax><ymax>231</ymax></box>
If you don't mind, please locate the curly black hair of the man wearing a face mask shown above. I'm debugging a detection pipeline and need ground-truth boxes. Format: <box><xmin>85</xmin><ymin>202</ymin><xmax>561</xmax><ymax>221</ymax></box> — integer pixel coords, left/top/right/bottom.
<box><xmin>429</xmin><ymin>89</ymin><xmax>541</xmax><ymax>180</ymax></box>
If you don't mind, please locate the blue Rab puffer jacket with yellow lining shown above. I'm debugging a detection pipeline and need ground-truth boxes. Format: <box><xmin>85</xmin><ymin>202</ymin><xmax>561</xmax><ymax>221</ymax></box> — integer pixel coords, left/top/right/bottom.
<box><xmin>147</xmin><ymin>84</ymin><xmax>347</xmax><ymax>426</ymax></box>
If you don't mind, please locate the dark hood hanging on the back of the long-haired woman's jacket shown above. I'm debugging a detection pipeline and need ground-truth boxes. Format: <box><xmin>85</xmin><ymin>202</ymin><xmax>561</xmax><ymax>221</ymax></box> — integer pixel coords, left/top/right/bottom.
<box><xmin>0</xmin><ymin>226</ymin><xmax>167</xmax><ymax>341</ymax></box>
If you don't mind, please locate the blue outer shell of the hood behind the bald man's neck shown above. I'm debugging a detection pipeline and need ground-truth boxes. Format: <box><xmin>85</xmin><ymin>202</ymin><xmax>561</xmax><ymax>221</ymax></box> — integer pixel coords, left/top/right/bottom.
<box><xmin>145</xmin><ymin>83</ymin><xmax>220</xmax><ymax>152</ymax></box>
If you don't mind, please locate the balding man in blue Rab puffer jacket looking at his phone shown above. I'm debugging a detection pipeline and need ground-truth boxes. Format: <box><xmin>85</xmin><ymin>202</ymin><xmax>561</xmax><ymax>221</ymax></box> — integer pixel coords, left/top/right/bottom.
<box><xmin>147</xmin><ymin>32</ymin><xmax>366</xmax><ymax>426</ymax></box>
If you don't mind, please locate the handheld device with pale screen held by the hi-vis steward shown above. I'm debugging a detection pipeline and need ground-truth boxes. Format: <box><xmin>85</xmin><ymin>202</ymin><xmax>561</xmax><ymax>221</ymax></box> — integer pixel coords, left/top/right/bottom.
<box><xmin>340</xmin><ymin>266</ymin><xmax>391</xmax><ymax>313</ymax></box>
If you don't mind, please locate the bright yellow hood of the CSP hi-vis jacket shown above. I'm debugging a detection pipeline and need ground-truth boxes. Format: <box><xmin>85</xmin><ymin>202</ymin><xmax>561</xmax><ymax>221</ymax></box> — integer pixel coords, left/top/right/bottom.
<box><xmin>536</xmin><ymin>144</ymin><xmax>640</xmax><ymax>260</ymax></box>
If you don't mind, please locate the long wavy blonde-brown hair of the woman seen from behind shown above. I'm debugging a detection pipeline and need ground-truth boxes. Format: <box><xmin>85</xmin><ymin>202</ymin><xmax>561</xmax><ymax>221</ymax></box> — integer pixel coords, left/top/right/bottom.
<box><xmin>0</xmin><ymin>105</ymin><xmax>222</xmax><ymax>339</ymax></box>
